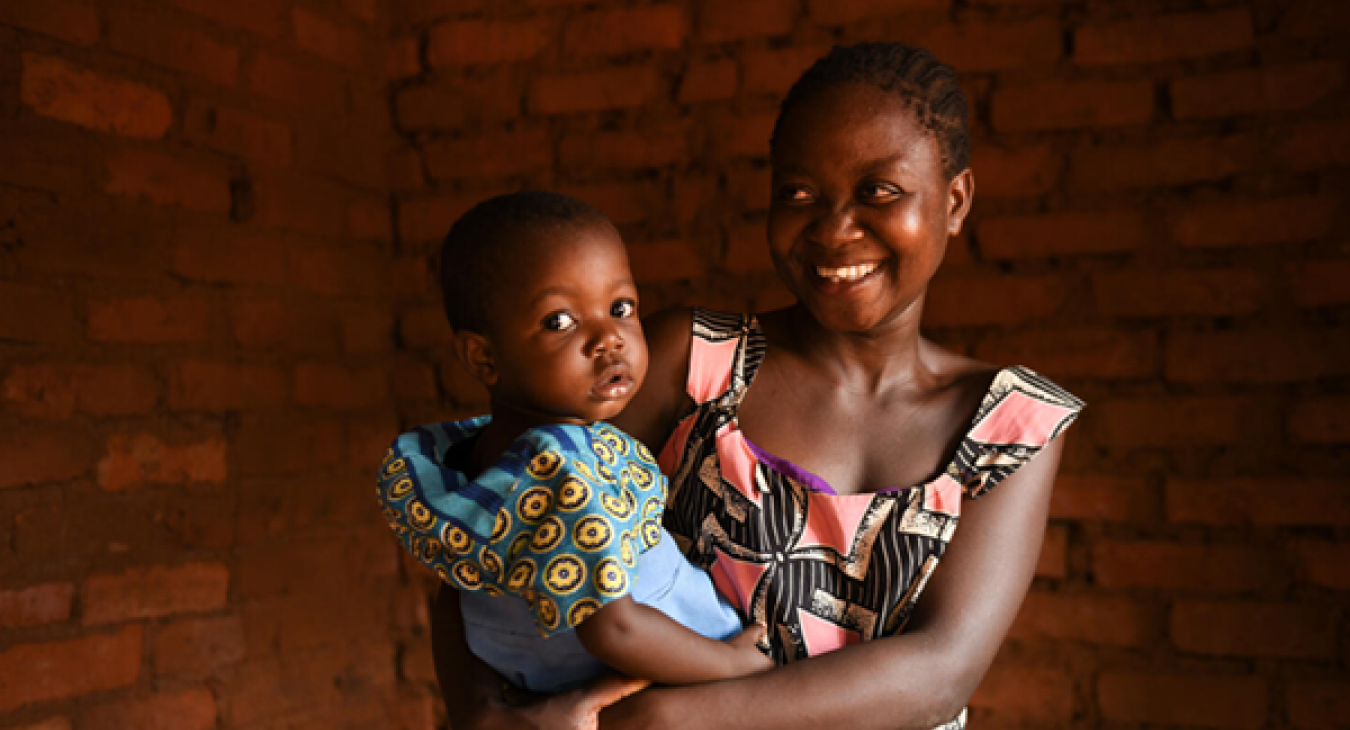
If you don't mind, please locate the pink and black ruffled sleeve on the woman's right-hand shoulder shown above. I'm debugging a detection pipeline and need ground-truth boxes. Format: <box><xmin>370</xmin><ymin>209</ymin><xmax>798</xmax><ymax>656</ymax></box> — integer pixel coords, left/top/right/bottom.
<box><xmin>948</xmin><ymin>367</ymin><xmax>1084</xmax><ymax>498</ymax></box>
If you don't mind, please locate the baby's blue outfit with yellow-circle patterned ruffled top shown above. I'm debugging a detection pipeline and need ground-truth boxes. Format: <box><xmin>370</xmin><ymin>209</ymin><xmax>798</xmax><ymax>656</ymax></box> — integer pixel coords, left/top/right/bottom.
<box><xmin>377</xmin><ymin>416</ymin><xmax>741</xmax><ymax>692</ymax></box>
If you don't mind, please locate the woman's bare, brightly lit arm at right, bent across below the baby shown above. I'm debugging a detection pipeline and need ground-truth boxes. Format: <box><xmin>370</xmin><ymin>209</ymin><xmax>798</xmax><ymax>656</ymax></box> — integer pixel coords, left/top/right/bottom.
<box><xmin>601</xmin><ymin>437</ymin><xmax>1062</xmax><ymax>730</ymax></box>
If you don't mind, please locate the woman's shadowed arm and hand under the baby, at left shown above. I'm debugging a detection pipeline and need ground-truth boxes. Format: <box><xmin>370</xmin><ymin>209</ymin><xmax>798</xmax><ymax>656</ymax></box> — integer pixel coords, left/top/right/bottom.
<box><xmin>431</xmin><ymin>586</ymin><xmax>648</xmax><ymax>730</ymax></box>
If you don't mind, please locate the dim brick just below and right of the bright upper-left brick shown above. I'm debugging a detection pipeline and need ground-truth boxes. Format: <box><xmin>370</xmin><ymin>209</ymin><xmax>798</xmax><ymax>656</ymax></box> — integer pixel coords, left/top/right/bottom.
<box><xmin>104</xmin><ymin>150</ymin><xmax>231</xmax><ymax>213</ymax></box>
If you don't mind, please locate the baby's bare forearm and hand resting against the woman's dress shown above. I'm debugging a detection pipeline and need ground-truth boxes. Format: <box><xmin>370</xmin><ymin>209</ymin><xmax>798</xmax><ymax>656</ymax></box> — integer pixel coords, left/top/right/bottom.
<box><xmin>576</xmin><ymin>596</ymin><xmax>774</xmax><ymax>684</ymax></box>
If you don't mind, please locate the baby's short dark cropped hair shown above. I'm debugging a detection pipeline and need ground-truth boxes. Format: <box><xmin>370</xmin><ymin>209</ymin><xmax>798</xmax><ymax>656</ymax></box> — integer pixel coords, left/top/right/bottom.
<box><xmin>440</xmin><ymin>190</ymin><xmax>613</xmax><ymax>333</ymax></box>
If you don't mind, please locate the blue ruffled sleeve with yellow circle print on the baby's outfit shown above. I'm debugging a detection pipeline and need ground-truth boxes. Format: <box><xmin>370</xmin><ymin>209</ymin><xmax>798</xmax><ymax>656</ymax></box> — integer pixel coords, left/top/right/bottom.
<box><xmin>379</xmin><ymin>424</ymin><xmax>666</xmax><ymax>636</ymax></box>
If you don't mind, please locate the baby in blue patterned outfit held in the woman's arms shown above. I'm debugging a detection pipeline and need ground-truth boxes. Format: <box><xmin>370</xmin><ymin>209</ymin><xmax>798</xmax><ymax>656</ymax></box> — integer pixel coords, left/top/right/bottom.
<box><xmin>378</xmin><ymin>193</ymin><xmax>771</xmax><ymax>692</ymax></box>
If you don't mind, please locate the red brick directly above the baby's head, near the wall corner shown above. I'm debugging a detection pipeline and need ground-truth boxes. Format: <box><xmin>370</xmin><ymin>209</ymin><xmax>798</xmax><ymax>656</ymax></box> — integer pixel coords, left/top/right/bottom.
<box><xmin>424</xmin><ymin>130</ymin><xmax>554</xmax><ymax>180</ymax></box>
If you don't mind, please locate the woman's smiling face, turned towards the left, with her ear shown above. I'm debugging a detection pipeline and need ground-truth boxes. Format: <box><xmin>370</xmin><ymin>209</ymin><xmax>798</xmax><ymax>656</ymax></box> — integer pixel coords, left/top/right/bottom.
<box><xmin>768</xmin><ymin>84</ymin><xmax>972</xmax><ymax>332</ymax></box>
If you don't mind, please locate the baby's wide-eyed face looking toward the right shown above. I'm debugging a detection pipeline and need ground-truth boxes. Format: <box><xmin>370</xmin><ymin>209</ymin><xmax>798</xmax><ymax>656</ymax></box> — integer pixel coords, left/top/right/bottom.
<box><xmin>489</xmin><ymin>223</ymin><xmax>647</xmax><ymax>422</ymax></box>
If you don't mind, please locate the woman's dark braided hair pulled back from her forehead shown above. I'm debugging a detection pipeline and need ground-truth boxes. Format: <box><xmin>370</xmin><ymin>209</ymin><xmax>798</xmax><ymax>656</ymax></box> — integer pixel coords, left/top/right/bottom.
<box><xmin>770</xmin><ymin>43</ymin><xmax>971</xmax><ymax>179</ymax></box>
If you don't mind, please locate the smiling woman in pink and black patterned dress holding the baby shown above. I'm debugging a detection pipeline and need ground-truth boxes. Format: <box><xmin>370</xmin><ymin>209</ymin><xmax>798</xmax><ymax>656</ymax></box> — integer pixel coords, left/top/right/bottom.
<box><xmin>435</xmin><ymin>43</ymin><xmax>1081</xmax><ymax>730</ymax></box>
